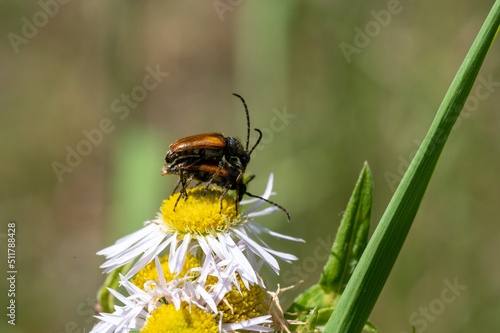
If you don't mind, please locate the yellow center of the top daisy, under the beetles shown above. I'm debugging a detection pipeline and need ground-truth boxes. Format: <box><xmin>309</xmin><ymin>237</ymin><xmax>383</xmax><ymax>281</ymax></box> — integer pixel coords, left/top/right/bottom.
<box><xmin>161</xmin><ymin>187</ymin><xmax>241</xmax><ymax>235</ymax></box>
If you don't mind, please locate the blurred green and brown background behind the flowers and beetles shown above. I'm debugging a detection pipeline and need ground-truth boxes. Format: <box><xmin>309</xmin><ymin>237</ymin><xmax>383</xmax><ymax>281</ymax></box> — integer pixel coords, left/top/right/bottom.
<box><xmin>0</xmin><ymin>0</ymin><xmax>500</xmax><ymax>333</ymax></box>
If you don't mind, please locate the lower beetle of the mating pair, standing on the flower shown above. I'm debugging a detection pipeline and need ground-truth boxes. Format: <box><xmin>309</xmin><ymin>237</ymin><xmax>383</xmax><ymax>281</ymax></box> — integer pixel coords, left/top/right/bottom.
<box><xmin>164</xmin><ymin>161</ymin><xmax>290</xmax><ymax>222</ymax></box>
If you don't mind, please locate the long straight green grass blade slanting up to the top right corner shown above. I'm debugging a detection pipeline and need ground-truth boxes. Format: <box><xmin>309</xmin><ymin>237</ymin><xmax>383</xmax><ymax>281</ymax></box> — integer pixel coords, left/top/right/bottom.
<box><xmin>325</xmin><ymin>0</ymin><xmax>500</xmax><ymax>332</ymax></box>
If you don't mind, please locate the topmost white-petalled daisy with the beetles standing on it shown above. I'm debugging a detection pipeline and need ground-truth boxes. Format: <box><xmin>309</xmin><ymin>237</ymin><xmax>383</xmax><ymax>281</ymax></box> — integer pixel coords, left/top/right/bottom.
<box><xmin>97</xmin><ymin>174</ymin><xmax>303</xmax><ymax>288</ymax></box>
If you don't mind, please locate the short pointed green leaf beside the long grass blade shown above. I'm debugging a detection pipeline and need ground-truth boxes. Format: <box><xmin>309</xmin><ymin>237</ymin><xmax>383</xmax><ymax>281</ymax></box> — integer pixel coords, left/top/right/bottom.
<box><xmin>319</xmin><ymin>162</ymin><xmax>373</xmax><ymax>295</ymax></box>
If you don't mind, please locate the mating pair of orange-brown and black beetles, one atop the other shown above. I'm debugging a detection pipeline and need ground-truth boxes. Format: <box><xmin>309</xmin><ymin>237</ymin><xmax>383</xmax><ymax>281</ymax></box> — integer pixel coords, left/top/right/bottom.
<box><xmin>161</xmin><ymin>94</ymin><xmax>290</xmax><ymax>220</ymax></box>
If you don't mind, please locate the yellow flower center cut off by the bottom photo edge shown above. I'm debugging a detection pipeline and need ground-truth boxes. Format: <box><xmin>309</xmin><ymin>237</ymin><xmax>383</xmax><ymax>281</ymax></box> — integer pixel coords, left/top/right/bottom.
<box><xmin>141</xmin><ymin>304</ymin><xmax>219</xmax><ymax>333</ymax></box>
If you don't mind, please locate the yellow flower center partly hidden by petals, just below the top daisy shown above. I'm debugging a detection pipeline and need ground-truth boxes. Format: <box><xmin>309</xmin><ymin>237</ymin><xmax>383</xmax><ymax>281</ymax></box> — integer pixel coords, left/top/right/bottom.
<box><xmin>131</xmin><ymin>253</ymin><xmax>200</xmax><ymax>290</ymax></box>
